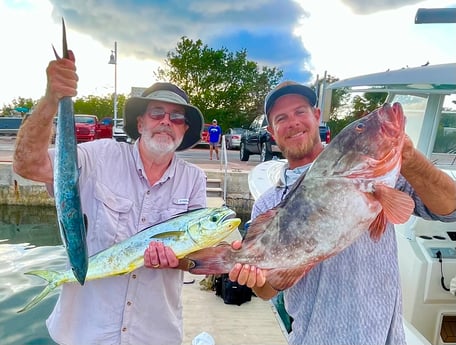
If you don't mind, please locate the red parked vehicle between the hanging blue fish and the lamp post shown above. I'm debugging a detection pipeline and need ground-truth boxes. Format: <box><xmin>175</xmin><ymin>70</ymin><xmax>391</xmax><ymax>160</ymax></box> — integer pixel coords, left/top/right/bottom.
<box><xmin>74</xmin><ymin>114</ymin><xmax>113</xmax><ymax>143</ymax></box>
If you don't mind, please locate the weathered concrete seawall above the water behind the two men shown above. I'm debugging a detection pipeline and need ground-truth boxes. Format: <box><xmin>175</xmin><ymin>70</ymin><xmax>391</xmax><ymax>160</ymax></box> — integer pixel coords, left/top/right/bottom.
<box><xmin>0</xmin><ymin>162</ymin><xmax>254</xmax><ymax>213</ymax></box>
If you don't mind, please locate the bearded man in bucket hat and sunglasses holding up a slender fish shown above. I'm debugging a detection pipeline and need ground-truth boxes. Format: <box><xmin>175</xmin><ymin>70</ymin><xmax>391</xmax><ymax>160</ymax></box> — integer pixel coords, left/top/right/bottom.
<box><xmin>14</xmin><ymin>54</ymin><xmax>206</xmax><ymax>345</ymax></box>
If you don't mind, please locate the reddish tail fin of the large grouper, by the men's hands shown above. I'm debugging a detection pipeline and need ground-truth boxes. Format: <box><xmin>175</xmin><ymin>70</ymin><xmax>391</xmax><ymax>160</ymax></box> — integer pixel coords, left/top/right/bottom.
<box><xmin>185</xmin><ymin>243</ymin><xmax>234</xmax><ymax>274</ymax></box>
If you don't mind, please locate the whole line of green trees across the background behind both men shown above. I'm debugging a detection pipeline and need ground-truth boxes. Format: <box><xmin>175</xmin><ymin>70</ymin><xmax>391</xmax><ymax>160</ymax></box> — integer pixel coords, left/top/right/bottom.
<box><xmin>1</xmin><ymin>36</ymin><xmax>386</xmax><ymax>136</ymax></box>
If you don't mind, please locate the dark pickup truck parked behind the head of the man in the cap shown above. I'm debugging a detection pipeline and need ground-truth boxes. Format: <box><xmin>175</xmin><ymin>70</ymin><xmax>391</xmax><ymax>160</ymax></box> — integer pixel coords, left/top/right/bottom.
<box><xmin>239</xmin><ymin>114</ymin><xmax>331</xmax><ymax>162</ymax></box>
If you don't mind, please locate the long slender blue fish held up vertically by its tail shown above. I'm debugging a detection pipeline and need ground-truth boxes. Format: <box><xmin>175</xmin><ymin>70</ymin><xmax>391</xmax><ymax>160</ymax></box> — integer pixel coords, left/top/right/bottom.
<box><xmin>54</xmin><ymin>19</ymin><xmax>89</xmax><ymax>285</ymax></box>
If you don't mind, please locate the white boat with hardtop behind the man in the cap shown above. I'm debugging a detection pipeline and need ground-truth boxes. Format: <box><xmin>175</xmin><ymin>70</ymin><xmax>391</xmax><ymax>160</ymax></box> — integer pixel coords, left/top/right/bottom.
<box><xmin>249</xmin><ymin>63</ymin><xmax>456</xmax><ymax>345</ymax></box>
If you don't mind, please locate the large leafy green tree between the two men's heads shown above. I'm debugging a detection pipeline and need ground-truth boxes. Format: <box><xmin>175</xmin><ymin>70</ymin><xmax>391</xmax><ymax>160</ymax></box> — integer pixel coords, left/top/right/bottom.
<box><xmin>155</xmin><ymin>37</ymin><xmax>283</xmax><ymax>130</ymax></box>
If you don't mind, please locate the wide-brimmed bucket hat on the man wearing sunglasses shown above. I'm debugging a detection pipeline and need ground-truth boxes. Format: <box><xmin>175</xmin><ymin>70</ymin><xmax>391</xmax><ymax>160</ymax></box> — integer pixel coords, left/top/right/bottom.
<box><xmin>124</xmin><ymin>82</ymin><xmax>204</xmax><ymax>151</ymax></box>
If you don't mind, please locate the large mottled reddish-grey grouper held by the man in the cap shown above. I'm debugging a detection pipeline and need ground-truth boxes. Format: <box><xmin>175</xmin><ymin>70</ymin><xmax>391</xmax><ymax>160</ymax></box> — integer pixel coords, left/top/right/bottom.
<box><xmin>187</xmin><ymin>103</ymin><xmax>414</xmax><ymax>290</ymax></box>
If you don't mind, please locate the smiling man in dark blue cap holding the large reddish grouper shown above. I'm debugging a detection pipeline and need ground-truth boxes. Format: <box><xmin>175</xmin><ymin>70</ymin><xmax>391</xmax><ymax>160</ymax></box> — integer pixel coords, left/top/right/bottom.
<box><xmin>229</xmin><ymin>81</ymin><xmax>456</xmax><ymax>345</ymax></box>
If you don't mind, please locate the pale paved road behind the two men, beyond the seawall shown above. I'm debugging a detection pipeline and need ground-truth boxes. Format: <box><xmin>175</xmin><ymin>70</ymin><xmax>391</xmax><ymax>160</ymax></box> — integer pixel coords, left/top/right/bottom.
<box><xmin>0</xmin><ymin>135</ymin><xmax>260</xmax><ymax>171</ymax></box>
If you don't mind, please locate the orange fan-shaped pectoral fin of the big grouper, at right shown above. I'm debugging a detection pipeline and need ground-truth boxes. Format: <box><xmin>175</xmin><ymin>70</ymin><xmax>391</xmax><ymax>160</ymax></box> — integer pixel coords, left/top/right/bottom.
<box><xmin>374</xmin><ymin>185</ymin><xmax>415</xmax><ymax>224</ymax></box>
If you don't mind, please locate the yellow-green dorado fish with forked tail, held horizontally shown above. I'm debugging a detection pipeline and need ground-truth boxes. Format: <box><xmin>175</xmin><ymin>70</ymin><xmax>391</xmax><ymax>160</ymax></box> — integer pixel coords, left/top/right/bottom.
<box><xmin>18</xmin><ymin>207</ymin><xmax>241</xmax><ymax>312</ymax></box>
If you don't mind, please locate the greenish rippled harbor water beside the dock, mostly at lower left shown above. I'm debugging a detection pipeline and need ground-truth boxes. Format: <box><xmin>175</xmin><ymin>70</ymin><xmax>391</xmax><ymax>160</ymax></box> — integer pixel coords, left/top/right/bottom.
<box><xmin>0</xmin><ymin>206</ymin><xmax>249</xmax><ymax>345</ymax></box>
